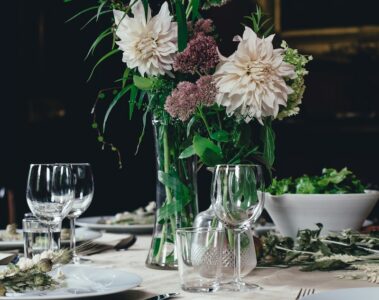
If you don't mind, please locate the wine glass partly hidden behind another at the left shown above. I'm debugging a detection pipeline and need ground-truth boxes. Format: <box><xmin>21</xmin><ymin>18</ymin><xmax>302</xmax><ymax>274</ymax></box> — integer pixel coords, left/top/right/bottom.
<box><xmin>67</xmin><ymin>163</ymin><xmax>94</xmax><ymax>264</ymax></box>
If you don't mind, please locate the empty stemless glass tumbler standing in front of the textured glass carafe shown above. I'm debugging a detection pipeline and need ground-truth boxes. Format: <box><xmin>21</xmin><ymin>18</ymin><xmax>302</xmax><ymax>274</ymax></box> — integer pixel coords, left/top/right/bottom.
<box><xmin>176</xmin><ymin>228</ymin><xmax>224</xmax><ymax>292</ymax></box>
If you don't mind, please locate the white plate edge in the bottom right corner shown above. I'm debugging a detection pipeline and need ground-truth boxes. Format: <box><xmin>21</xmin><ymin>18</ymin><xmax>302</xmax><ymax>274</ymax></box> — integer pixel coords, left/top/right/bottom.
<box><xmin>301</xmin><ymin>288</ymin><xmax>379</xmax><ymax>300</ymax></box>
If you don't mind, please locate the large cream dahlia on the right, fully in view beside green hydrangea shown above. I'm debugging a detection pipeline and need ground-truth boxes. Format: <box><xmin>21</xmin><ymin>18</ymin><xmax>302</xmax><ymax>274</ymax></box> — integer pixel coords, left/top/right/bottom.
<box><xmin>214</xmin><ymin>27</ymin><xmax>296</xmax><ymax>123</ymax></box>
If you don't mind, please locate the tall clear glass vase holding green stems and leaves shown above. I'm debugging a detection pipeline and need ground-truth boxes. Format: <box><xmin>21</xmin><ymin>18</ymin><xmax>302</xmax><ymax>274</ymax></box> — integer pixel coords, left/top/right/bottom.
<box><xmin>146</xmin><ymin>117</ymin><xmax>198</xmax><ymax>269</ymax></box>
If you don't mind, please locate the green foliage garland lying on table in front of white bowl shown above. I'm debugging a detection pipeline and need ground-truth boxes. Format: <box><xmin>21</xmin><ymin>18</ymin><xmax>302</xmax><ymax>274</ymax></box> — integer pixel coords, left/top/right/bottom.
<box><xmin>258</xmin><ymin>224</ymin><xmax>379</xmax><ymax>271</ymax></box>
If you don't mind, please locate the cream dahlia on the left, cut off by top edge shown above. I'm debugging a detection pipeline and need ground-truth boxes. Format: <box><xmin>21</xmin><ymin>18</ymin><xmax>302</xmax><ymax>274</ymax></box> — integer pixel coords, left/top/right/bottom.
<box><xmin>113</xmin><ymin>1</ymin><xmax>177</xmax><ymax>76</ymax></box>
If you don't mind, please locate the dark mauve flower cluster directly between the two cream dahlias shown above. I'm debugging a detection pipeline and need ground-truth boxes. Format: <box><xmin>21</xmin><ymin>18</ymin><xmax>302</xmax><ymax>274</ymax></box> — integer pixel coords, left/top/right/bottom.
<box><xmin>174</xmin><ymin>33</ymin><xmax>220</xmax><ymax>74</ymax></box>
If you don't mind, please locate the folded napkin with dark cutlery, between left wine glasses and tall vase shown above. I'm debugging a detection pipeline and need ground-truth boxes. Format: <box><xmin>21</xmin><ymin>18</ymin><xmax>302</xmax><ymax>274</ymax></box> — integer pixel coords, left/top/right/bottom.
<box><xmin>78</xmin><ymin>233</ymin><xmax>137</xmax><ymax>256</ymax></box>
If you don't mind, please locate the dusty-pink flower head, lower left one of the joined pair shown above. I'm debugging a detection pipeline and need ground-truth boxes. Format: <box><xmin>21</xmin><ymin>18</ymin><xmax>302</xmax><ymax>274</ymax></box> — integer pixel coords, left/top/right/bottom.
<box><xmin>165</xmin><ymin>81</ymin><xmax>198</xmax><ymax>122</ymax></box>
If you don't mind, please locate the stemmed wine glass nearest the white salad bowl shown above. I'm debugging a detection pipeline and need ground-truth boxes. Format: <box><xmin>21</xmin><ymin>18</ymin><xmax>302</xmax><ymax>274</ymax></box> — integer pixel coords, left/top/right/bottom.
<box><xmin>212</xmin><ymin>165</ymin><xmax>264</xmax><ymax>291</ymax></box>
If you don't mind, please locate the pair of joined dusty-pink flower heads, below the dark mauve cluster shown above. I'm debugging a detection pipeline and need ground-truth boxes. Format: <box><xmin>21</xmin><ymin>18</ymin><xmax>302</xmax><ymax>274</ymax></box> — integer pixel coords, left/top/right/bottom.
<box><xmin>165</xmin><ymin>76</ymin><xmax>217</xmax><ymax>122</ymax></box>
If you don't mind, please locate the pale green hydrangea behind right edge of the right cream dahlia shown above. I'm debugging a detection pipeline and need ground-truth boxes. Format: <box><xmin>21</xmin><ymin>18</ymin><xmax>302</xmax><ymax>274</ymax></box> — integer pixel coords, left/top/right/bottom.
<box><xmin>277</xmin><ymin>41</ymin><xmax>313</xmax><ymax>120</ymax></box>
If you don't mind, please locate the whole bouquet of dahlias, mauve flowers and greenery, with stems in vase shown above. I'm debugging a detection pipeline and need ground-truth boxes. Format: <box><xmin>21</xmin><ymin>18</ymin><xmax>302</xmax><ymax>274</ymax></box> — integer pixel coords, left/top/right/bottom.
<box><xmin>66</xmin><ymin>0</ymin><xmax>312</xmax><ymax>265</ymax></box>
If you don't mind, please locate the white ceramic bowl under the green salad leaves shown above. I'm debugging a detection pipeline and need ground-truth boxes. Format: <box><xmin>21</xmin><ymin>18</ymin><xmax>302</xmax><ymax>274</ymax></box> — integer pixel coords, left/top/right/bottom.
<box><xmin>265</xmin><ymin>190</ymin><xmax>379</xmax><ymax>238</ymax></box>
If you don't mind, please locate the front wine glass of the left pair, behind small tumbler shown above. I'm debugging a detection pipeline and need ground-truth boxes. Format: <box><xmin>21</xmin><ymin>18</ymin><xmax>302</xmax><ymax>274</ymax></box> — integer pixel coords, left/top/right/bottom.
<box><xmin>26</xmin><ymin>164</ymin><xmax>74</xmax><ymax>250</ymax></box>
